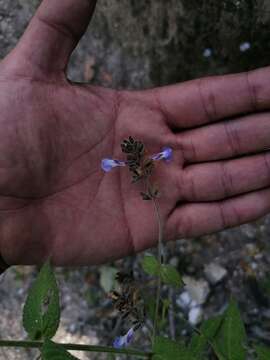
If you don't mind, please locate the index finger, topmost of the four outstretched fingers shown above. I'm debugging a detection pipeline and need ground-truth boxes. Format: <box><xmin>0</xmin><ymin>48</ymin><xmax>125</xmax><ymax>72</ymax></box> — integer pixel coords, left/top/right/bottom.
<box><xmin>148</xmin><ymin>67</ymin><xmax>270</xmax><ymax>129</ymax></box>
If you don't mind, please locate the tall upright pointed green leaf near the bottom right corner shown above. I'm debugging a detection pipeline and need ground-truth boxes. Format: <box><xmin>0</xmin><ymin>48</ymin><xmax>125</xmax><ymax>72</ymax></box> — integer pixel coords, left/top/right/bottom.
<box><xmin>214</xmin><ymin>300</ymin><xmax>246</xmax><ymax>360</ymax></box>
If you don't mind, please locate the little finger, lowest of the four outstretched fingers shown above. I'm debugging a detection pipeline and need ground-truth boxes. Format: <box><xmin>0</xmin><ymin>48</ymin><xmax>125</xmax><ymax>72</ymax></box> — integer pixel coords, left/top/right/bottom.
<box><xmin>167</xmin><ymin>189</ymin><xmax>270</xmax><ymax>239</ymax></box>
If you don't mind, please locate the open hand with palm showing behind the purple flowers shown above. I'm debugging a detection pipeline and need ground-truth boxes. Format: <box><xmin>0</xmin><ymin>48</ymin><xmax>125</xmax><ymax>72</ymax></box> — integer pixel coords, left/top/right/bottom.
<box><xmin>0</xmin><ymin>0</ymin><xmax>270</xmax><ymax>265</ymax></box>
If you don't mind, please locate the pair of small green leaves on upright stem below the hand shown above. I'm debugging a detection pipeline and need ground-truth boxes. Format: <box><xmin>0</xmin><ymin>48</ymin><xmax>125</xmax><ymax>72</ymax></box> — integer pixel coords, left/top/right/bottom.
<box><xmin>142</xmin><ymin>255</ymin><xmax>183</xmax><ymax>288</ymax></box>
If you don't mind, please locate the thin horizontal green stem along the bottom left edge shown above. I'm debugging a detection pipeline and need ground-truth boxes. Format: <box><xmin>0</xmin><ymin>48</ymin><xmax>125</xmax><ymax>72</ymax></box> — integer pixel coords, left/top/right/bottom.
<box><xmin>0</xmin><ymin>340</ymin><xmax>152</xmax><ymax>359</ymax></box>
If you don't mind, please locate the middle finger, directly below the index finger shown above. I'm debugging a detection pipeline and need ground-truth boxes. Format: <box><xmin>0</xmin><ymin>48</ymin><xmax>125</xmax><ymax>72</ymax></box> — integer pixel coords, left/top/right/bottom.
<box><xmin>176</xmin><ymin>112</ymin><xmax>270</xmax><ymax>164</ymax></box>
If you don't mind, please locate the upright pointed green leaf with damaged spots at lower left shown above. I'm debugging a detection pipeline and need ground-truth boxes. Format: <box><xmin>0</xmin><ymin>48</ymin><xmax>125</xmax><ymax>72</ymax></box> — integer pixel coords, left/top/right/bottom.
<box><xmin>23</xmin><ymin>261</ymin><xmax>60</xmax><ymax>340</ymax></box>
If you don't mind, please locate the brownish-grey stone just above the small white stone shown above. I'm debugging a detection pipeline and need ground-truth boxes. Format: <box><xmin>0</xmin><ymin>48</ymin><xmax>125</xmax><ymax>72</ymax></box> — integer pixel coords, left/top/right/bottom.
<box><xmin>183</xmin><ymin>276</ymin><xmax>210</xmax><ymax>305</ymax></box>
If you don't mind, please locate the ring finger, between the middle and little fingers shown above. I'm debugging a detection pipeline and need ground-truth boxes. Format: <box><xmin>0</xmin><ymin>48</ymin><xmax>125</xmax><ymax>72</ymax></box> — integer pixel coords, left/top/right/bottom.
<box><xmin>177</xmin><ymin>152</ymin><xmax>270</xmax><ymax>202</ymax></box>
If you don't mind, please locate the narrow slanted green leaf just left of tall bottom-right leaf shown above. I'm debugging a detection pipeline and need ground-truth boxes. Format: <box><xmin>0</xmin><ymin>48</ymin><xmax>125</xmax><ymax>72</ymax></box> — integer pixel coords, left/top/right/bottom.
<box><xmin>189</xmin><ymin>316</ymin><xmax>222</xmax><ymax>359</ymax></box>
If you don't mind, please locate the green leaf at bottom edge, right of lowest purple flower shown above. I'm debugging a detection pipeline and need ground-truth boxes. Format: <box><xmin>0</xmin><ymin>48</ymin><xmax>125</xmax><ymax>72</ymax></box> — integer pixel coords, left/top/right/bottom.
<box><xmin>153</xmin><ymin>336</ymin><xmax>196</xmax><ymax>360</ymax></box>
